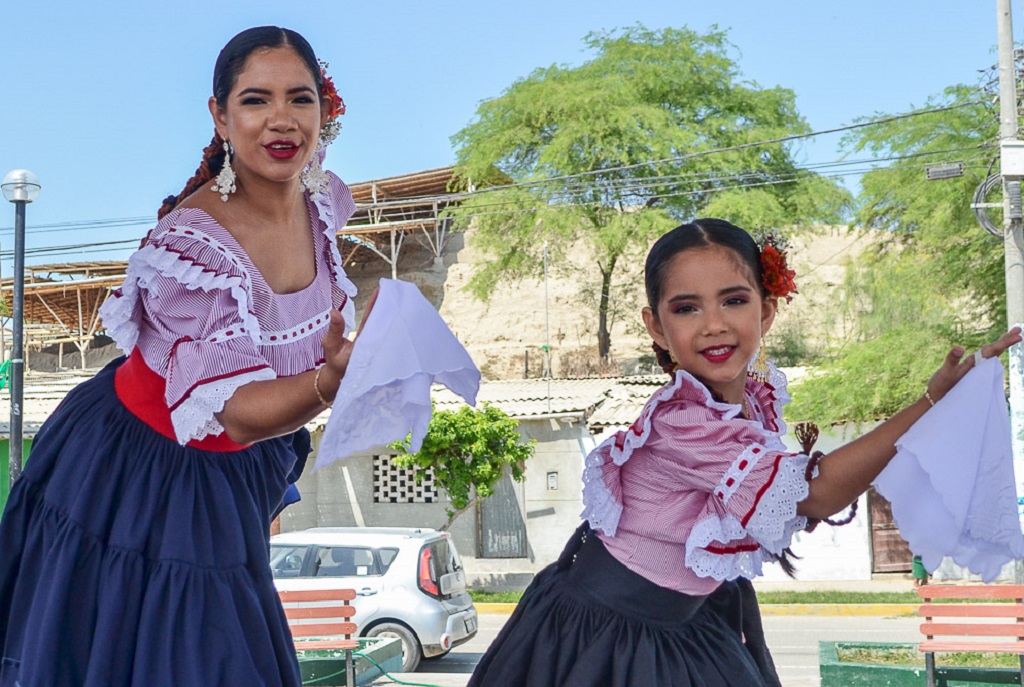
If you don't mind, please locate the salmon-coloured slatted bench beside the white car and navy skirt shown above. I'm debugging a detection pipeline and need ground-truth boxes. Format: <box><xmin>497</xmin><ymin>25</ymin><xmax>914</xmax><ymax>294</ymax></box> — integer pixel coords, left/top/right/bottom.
<box><xmin>278</xmin><ymin>589</ymin><xmax>359</xmax><ymax>685</ymax></box>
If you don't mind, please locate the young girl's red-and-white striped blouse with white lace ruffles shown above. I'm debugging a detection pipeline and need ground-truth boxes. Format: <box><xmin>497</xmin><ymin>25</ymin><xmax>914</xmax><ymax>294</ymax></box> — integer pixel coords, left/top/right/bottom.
<box><xmin>583</xmin><ymin>367</ymin><xmax>808</xmax><ymax>594</ymax></box>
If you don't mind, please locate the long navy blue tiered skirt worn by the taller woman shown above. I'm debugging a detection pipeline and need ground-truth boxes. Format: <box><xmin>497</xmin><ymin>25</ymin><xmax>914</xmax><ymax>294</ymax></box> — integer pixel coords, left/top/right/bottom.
<box><xmin>0</xmin><ymin>358</ymin><xmax>309</xmax><ymax>687</ymax></box>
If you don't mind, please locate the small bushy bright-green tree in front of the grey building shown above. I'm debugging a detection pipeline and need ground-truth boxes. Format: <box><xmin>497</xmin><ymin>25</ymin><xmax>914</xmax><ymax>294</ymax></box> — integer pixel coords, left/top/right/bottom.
<box><xmin>391</xmin><ymin>403</ymin><xmax>535</xmax><ymax>529</ymax></box>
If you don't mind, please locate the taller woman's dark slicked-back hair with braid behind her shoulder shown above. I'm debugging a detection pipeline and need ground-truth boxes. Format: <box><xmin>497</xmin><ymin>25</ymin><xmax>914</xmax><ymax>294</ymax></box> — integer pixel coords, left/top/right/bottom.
<box><xmin>157</xmin><ymin>27</ymin><xmax>324</xmax><ymax>219</ymax></box>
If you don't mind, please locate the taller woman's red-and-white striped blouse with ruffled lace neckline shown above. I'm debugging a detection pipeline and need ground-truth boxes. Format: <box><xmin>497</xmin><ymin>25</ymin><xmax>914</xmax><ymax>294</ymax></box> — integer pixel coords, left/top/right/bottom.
<box><xmin>100</xmin><ymin>174</ymin><xmax>356</xmax><ymax>444</ymax></box>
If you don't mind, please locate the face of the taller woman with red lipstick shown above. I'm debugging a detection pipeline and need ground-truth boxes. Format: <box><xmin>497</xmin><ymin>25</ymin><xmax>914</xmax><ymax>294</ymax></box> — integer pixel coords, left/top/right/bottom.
<box><xmin>210</xmin><ymin>46</ymin><xmax>325</xmax><ymax>185</ymax></box>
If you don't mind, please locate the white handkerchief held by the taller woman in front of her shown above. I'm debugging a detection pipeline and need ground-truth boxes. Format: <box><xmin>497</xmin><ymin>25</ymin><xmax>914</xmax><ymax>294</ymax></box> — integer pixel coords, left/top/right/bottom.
<box><xmin>313</xmin><ymin>280</ymin><xmax>480</xmax><ymax>470</ymax></box>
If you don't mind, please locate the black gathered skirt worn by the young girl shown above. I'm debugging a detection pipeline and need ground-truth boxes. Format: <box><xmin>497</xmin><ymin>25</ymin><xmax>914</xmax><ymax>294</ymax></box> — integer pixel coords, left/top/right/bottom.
<box><xmin>468</xmin><ymin>523</ymin><xmax>779</xmax><ymax>687</ymax></box>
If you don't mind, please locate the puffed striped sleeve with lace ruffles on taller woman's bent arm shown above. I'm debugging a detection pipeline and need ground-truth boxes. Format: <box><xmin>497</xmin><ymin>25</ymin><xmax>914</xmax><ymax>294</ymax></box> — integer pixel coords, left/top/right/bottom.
<box><xmin>100</xmin><ymin>224</ymin><xmax>276</xmax><ymax>444</ymax></box>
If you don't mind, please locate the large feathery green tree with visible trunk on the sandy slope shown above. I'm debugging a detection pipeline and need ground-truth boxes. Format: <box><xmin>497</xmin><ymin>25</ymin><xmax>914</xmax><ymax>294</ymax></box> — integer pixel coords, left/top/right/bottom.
<box><xmin>452</xmin><ymin>26</ymin><xmax>850</xmax><ymax>358</ymax></box>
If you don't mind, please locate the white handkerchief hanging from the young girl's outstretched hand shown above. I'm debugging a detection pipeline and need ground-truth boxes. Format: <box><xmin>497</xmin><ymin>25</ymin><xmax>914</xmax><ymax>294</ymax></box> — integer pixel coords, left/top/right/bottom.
<box><xmin>874</xmin><ymin>358</ymin><xmax>1024</xmax><ymax>583</ymax></box>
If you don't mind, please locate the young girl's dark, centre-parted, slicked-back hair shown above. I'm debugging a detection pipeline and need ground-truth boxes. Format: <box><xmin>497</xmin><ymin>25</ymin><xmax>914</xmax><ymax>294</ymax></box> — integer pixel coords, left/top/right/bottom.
<box><xmin>644</xmin><ymin>218</ymin><xmax>768</xmax><ymax>375</ymax></box>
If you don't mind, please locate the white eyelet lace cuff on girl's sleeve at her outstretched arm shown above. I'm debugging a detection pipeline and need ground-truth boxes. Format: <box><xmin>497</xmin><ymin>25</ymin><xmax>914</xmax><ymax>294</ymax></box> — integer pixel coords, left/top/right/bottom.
<box><xmin>686</xmin><ymin>455</ymin><xmax>809</xmax><ymax>581</ymax></box>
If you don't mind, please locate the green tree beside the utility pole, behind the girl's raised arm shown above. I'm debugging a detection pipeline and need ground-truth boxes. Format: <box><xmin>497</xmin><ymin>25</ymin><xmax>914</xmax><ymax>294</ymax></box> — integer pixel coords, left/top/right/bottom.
<box><xmin>786</xmin><ymin>85</ymin><xmax>1006</xmax><ymax>424</ymax></box>
